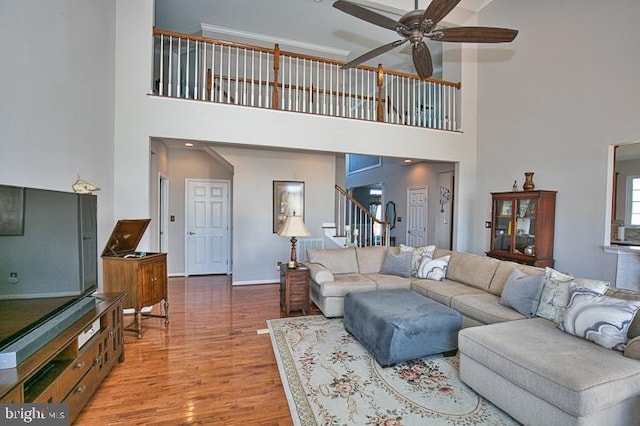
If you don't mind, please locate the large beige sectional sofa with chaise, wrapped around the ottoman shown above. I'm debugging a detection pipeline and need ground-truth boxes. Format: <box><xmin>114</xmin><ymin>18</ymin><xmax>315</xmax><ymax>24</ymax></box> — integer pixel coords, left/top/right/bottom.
<box><xmin>306</xmin><ymin>247</ymin><xmax>640</xmax><ymax>425</ymax></box>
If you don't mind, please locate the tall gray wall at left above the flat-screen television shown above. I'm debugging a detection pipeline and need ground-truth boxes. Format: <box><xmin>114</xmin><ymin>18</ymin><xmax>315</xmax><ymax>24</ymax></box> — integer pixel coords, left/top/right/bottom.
<box><xmin>0</xmin><ymin>0</ymin><xmax>116</xmax><ymax>290</ymax></box>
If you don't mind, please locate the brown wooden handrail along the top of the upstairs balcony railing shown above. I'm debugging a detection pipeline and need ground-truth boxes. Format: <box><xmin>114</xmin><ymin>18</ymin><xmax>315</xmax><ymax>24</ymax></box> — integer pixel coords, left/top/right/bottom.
<box><xmin>153</xmin><ymin>28</ymin><xmax>462</xmax><ymax>89</ymax></box>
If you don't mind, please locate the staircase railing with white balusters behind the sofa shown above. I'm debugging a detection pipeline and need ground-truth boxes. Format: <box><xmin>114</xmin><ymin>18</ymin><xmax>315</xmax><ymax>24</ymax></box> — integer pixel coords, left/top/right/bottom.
<box><xmin>335</xmin><ymin>185</ymin><xmax>391</xmax><ymax>247</ymax></box>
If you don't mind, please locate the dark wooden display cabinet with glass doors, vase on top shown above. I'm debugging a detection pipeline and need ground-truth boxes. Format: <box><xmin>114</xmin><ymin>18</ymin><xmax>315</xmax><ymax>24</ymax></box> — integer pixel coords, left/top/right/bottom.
<box><xmin>487</xmin><ymin>191</ymin><xmax>557</xmax><ymax>267</ymax></box>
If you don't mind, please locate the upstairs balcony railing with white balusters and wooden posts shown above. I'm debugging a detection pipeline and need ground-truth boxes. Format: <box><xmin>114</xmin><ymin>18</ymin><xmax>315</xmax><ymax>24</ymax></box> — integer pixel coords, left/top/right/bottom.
<box><xmin>153</xmin><ymin>29</ymin><xmax>461</xmax><ymax>131</ymax></box>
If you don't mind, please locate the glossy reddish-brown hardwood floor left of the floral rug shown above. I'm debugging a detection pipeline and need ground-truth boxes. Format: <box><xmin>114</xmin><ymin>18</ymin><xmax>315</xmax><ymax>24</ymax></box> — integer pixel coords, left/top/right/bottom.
<box><xmin>74</xmin><ymin>276</ymin><xmax>319</xmax><ymax>426</ymax></box>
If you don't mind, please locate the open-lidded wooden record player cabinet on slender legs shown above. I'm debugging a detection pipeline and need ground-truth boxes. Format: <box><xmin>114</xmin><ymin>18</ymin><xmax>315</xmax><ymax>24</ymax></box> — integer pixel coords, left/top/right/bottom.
<box><xmin>102</xmin><ymin>219</ymin><xmax>169</xmax><ymax>339</ymax></box>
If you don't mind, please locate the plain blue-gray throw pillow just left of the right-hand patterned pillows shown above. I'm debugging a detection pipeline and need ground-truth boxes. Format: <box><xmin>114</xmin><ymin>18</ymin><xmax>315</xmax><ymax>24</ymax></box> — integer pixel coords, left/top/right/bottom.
<box><xmin>500</xmin><ymin>269</ymin><xmax>544</xmax><ymax>318</ymax></box>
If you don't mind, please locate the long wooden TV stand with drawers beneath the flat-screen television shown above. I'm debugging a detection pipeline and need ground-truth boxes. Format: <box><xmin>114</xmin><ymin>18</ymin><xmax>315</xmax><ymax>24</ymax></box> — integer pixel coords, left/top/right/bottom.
<box><xmin>0</xmin><ymin>293</ymin><xmax>125</xmax><ymax>423</ymax></box>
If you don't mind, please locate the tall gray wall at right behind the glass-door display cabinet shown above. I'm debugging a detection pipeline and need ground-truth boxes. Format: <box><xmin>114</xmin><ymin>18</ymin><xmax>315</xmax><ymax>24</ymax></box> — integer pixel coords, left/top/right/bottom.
<box><xmin>472</xmin><ymin>0</ymin><xmax>640</xmax><ymax>281</ymax></box>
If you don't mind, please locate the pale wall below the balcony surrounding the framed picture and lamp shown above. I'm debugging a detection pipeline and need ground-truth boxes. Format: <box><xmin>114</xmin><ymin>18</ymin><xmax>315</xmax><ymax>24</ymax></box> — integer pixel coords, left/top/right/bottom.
<box><xmin>215</xmin><ymin>146</ymin><xmax>336</xmax><ymax>284</ymax></box>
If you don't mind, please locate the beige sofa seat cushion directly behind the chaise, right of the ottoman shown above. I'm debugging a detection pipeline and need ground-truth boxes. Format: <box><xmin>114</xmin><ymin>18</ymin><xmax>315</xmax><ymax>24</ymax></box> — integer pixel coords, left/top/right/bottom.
<box><xmin>451</xmin><ymin>292</ymin><xmax>525</xmax><ymax>324</ymax></box>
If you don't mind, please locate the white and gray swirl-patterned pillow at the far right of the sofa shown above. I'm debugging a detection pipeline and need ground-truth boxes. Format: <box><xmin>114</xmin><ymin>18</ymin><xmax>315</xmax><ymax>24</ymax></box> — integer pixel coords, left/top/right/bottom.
<box><xmin>558</xmin><ymin>287</ymin><xmax>640</xmax><ymax>351</ymax></box>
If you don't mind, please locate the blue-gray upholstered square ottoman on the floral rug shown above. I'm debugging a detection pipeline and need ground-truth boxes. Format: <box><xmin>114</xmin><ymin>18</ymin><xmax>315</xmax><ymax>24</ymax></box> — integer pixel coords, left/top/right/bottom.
<box><xmin>344</xmin><ymin>289</ymin><xmax>462</xmax><ymax>366</ymax></box>
